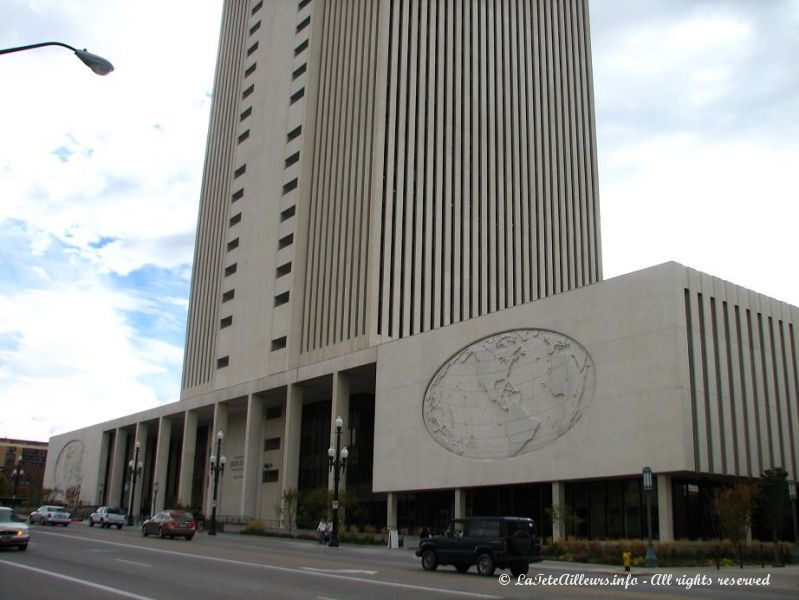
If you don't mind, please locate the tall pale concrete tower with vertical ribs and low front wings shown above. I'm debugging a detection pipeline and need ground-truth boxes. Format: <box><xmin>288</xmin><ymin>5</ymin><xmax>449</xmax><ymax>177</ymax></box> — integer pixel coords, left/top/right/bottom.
<box><xmin>45</xmin><ymin>0</ymin><xmax>799</xmax><ymax>540</ymax></box>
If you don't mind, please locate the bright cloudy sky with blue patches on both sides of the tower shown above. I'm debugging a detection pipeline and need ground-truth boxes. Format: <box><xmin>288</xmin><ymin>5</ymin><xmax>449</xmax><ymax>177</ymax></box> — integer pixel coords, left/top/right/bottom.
<box><xmin>0</xmin><ymin>0</ymin><xmax>799</xmax><ymax>440</ymax></box>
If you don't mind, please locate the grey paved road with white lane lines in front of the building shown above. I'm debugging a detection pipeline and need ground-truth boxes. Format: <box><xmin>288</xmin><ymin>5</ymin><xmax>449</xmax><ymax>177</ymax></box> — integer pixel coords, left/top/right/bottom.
<box><xmin>0</xmin><ymin>523</ymin><xmax>799</xmax><ymax>600</ymax></box>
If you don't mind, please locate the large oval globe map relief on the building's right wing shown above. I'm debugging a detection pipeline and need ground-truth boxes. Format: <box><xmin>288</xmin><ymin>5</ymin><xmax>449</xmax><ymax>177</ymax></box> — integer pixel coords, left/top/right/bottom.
<box><xmin>422</xmin><ymin>329</ymin><xmax>594</xmax><ymax>459</ymax></box>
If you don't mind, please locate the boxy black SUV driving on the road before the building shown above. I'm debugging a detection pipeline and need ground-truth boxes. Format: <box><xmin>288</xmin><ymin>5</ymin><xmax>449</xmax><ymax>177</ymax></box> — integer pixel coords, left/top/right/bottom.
<box><xmin>416</xmin><ymin>517</ymin><xmax>541</xmax><ymax>577</ymax></box>
